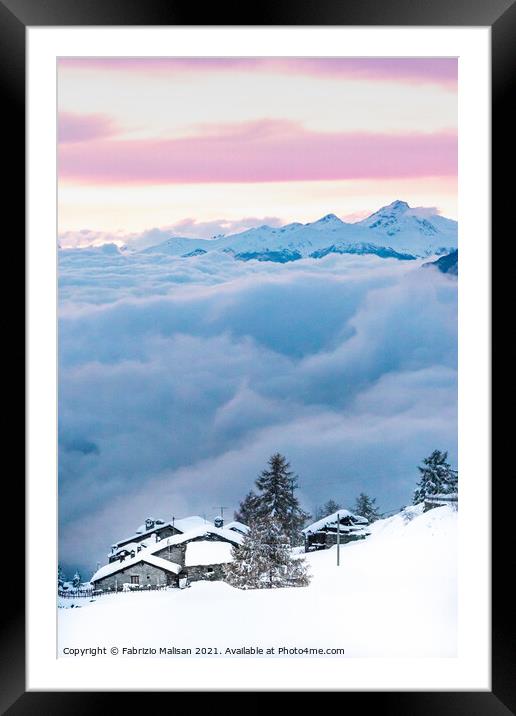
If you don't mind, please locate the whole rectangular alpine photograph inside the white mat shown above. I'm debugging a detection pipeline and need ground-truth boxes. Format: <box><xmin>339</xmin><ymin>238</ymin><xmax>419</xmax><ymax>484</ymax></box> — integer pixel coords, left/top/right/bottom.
<box><xmin>56</xmin><ymin>55</ymin><xmax>462</xmax><ymax>667</ymax></box>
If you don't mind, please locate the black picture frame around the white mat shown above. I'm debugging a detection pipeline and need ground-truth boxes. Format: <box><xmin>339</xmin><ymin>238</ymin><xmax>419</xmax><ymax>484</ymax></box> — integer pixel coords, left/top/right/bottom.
<box><xmin>6</xmin><ymin>0</ymin><xmax>516</xmax><ymax>716</ymax></box>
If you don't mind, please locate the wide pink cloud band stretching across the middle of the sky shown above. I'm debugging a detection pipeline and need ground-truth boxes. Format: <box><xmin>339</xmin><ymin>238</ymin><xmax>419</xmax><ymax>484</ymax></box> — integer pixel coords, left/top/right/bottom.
<box><xmin>59</xmin><ymin>125</ymin><xmax>457</xmax><ymax>185</ymax></box>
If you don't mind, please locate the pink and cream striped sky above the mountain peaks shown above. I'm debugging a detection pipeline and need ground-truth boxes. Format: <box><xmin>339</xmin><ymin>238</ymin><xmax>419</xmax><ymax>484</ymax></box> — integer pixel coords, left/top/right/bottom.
<box><xmin>58</xmin><ymin>58</ymin><xmax>457</xmax><ymax>238</ymax></box>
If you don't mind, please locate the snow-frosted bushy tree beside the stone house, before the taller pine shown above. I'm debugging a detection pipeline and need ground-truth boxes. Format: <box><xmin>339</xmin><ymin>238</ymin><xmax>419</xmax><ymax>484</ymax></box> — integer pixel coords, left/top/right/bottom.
<box><xmin>224</xmin><ymin>517</ymin><xmax>310</xmax><ymax>589</ymax></box>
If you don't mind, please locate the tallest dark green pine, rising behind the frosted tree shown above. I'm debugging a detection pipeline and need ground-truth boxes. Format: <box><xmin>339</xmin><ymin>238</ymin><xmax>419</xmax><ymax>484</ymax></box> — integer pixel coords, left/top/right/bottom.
<box><xmin>256</xmin><ymin>453</ymin><xmax>308</xmax><ymax>545</ymax></box>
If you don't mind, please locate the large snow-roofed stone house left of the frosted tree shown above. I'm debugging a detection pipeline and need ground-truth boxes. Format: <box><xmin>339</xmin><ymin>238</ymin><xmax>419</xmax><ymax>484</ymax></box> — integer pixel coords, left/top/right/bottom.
<box><xmin>90</xmin><ymin>518</ymin><xmax>242</xmax><ymax>591</ymax></box>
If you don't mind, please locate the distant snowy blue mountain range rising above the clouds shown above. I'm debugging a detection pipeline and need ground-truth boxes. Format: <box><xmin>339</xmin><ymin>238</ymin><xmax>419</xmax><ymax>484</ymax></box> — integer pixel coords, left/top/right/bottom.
<box><xmin>140</xmin><ymin>201</ymin><xmax>457</xmax><ymax>263</ymax></box>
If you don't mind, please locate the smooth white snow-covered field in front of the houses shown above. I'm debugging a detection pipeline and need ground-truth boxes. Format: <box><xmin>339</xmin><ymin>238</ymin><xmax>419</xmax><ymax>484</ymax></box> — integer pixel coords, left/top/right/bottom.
<box><xmin>58</xmin><ymin>507</ymin><xmax>457</xmax><ymax>657</ymax></box>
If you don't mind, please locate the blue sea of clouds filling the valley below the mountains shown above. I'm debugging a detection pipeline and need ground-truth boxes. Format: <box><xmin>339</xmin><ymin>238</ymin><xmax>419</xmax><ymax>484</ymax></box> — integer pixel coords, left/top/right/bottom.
<box><xmin>59</xmin><ymin>246</ymin><xmax>457</xmax><ymax>576</ymax></box>
